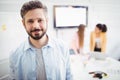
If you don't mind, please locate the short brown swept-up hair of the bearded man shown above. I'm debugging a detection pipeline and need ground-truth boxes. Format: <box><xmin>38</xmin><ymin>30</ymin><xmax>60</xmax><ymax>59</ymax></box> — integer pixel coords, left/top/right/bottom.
<box><xmin>20</xmin><ymin>0</ymin><xmax>47</xmax><ymax>18</ymax></box>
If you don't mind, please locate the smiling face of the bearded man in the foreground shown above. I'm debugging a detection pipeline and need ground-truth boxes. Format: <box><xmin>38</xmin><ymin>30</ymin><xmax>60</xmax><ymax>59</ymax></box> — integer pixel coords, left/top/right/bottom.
<box><xmin>23</xmin><ymin>9</ymin><xmax>47</xmax><ymax>40</ymax></box>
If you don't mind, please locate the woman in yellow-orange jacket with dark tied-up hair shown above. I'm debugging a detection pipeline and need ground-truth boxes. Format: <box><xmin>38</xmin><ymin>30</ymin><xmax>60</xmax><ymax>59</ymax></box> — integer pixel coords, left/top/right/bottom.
<box><xmin>90</xmin><ymin>24</ymin><xmax>107</xmax><ymax>53</ymax></box>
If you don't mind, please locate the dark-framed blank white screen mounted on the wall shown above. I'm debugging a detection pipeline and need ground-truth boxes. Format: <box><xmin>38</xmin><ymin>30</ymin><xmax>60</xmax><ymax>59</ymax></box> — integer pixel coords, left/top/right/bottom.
<box><xmin>54</xmin><ymin>6</ymin><xmax>88</xmax><ymax>28</ymax></box>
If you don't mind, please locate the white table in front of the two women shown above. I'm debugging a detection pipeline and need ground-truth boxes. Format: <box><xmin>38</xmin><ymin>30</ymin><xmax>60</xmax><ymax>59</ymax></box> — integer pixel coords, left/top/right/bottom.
<box><xmin>70</xmin><ymin>55</ymin><xmax>120</xmax><ymax>80</ymax></box>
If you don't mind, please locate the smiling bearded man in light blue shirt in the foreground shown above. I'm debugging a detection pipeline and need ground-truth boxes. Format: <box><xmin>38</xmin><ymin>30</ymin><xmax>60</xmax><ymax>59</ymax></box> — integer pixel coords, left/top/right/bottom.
<box><xmin>10</xmin><ymin>0</ymin><xmax>72</xmax><ymax>80</ymax></box>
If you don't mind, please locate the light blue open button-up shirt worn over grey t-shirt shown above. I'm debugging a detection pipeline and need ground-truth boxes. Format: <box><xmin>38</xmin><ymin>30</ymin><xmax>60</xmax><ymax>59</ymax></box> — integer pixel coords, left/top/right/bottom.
<box><xmin>10</xmin><ymin>35</ymin><xmax>72</xmax><ymax>80</ymax></box>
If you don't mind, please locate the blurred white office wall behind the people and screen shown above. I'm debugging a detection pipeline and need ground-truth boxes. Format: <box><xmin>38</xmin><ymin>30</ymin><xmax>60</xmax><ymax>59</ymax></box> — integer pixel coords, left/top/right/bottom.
<box><xmin>0</xmin><ymin>0</ymin><xmax>120</xmax><ymax>80</ymax></box>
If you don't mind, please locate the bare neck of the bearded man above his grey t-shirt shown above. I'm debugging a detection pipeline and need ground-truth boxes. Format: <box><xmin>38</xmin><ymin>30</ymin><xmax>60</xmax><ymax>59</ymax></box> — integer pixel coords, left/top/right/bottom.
<box><xmin>30</xmin><ymin>35</ymin><xmax>48</xmax><ymax>48</ymax></box>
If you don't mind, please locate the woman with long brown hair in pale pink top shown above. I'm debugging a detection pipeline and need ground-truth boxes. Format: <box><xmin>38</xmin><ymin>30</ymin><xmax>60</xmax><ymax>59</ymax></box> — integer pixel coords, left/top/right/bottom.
<box><xmin>70</xmin><ymin>24</ymin><xmax>85</xmax><ymax>54</ymax></box>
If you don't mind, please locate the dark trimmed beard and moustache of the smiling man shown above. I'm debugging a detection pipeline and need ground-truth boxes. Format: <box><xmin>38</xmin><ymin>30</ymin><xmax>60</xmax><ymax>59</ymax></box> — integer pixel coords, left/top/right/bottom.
<box><xmin>27</xmin><ymin>29</ymin><xmax>46</xmax><ymax>40</ymax></box>
